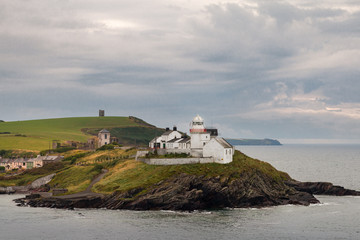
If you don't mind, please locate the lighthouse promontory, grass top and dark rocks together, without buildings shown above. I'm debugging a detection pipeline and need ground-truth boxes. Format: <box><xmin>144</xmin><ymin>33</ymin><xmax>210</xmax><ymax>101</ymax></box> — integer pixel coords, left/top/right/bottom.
<box><xmin>12</xmin><ymin>151</ymin><xmax>360</xmax><ymax>211</ymax></box>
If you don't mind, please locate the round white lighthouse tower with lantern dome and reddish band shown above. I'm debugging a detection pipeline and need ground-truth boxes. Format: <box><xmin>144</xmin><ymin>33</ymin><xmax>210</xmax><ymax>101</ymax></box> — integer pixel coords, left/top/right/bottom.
<box><xmin>190</xmin><ymin>115</ymin><xmax>210</xmax><ymax>157</ymax></box>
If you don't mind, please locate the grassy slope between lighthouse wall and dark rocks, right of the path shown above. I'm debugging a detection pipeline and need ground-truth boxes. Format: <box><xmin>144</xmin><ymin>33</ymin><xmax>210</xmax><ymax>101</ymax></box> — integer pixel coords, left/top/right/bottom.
<box><xmin>93</xmin><ymin>151</ymin><xmax>290</xmax><ymax>193</ymax></box>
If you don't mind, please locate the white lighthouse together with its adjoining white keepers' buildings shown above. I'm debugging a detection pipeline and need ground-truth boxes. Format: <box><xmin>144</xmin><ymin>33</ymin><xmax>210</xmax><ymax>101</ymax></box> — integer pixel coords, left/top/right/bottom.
<box><xmin>149</xmin><ymin>115</ymin><xmax>234</xmax><ymax>163</ymax></box>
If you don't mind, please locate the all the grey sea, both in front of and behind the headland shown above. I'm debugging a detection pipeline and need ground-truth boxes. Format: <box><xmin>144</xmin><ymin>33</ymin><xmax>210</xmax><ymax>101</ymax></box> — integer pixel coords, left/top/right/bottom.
<box><xmin>0</xmin><ymin>145</ymin><xmax>360</xmax><ymax>240</ymax></box>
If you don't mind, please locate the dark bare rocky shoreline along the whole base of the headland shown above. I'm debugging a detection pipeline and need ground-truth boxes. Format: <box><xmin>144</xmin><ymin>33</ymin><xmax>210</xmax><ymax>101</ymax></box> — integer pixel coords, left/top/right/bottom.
<box><xmin>15</xmin><ymin>171</ymin><xmax>360</xmax><ymax>211</ymax></box>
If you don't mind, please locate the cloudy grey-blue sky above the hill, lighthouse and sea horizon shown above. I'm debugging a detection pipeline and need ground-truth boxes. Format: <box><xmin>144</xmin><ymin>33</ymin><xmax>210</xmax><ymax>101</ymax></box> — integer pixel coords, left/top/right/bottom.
<box><xmin>0</xmin><ymin>0</ymin><xmax>360</xmax><ymax>142</ymax></box>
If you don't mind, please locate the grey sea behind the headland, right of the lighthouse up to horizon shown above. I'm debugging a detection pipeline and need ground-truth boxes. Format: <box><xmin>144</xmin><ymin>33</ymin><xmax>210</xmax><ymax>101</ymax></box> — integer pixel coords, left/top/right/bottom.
<box><xmin>236</xmin><ymin>145</ymin><xmax>360</xmax><ymax>191</ymax></box>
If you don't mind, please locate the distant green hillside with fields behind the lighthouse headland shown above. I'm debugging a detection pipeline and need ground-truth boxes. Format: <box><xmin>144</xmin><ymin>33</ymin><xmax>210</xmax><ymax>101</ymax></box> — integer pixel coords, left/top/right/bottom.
<box><xmin>0</xmin><ymin>117</ymin><xmax>161</xmax><ymax>150</ymax></box>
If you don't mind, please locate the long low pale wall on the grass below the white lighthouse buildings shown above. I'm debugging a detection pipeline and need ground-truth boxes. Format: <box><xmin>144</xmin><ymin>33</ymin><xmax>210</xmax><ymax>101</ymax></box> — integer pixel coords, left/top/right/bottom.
<box><xmin>138</xmin><ymin>157</ymin><xmax>215</xmax><ymax>165</ymax></box>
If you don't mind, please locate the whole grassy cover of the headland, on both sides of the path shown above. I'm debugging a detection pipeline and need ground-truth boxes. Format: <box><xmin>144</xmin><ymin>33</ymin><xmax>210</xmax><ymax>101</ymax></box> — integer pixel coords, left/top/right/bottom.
<box><xmin>0</xmin><ymin>150</ymin><xmax>290</xmax><ymax>194</ymax></box>
